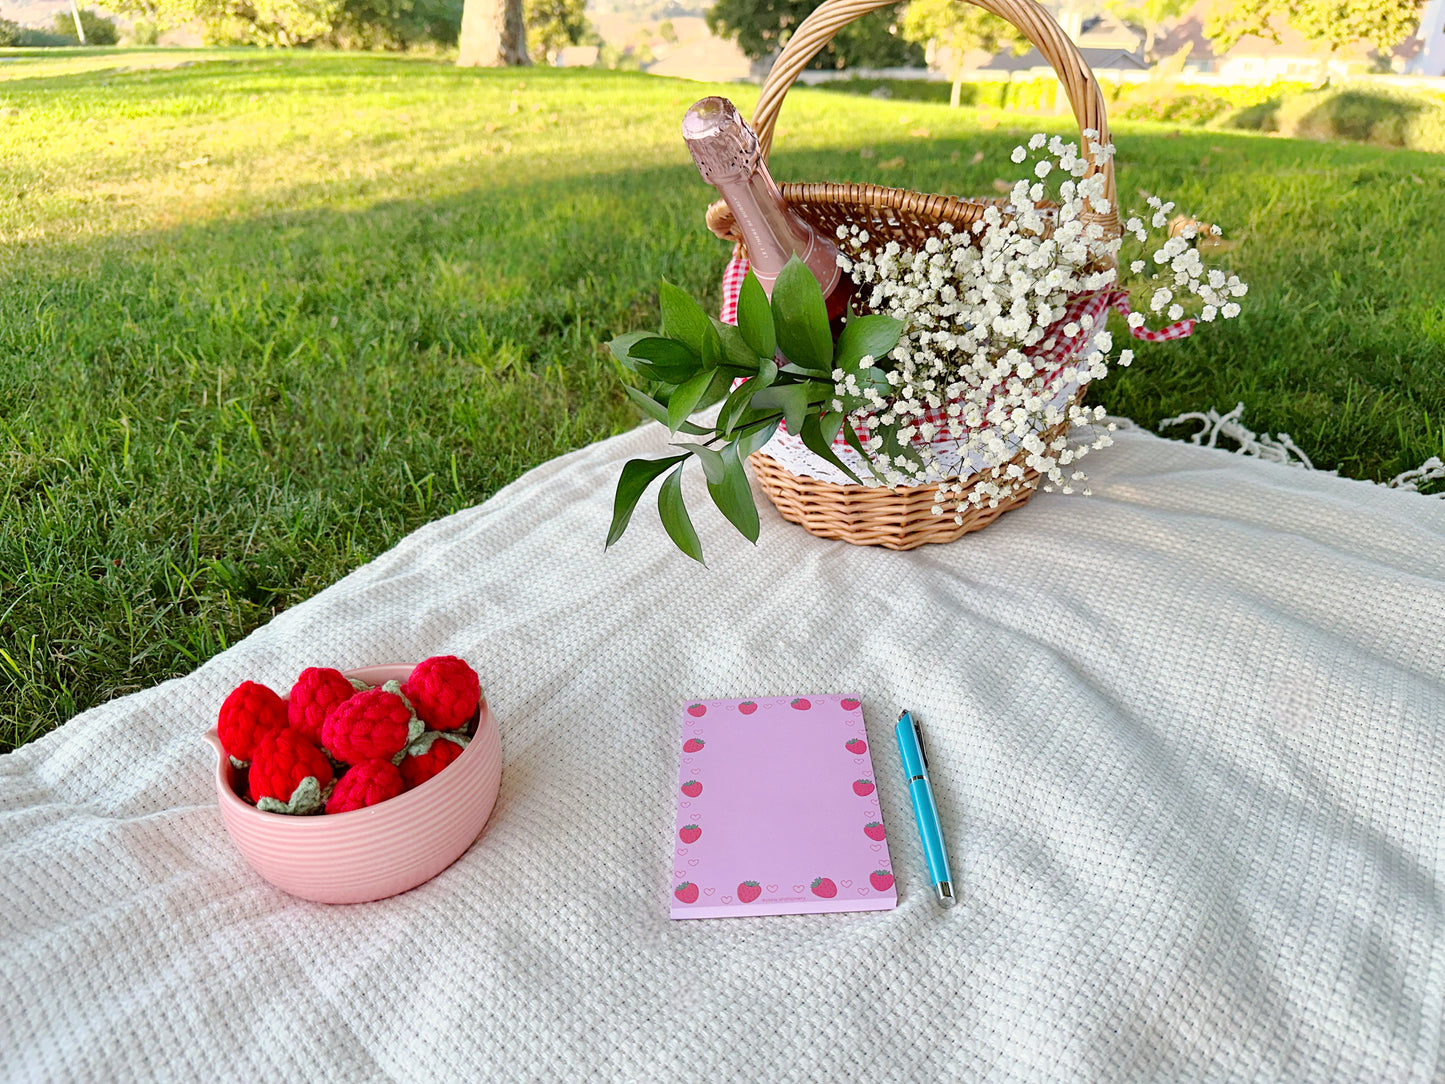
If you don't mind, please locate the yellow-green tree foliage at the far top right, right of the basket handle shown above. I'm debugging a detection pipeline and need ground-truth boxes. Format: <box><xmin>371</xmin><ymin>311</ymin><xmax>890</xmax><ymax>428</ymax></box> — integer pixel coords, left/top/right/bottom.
<box><xmin>1204</xmin><ymin>0</ymin><xmax>1420</xmax><ymax>52</ymax></box>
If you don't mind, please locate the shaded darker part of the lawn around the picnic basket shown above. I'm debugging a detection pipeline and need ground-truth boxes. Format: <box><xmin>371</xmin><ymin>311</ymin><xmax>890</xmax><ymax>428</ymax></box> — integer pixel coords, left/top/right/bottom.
<box><xmin>0</xmin><ymin>120</ymin><xmax>1445</xmax><ymax>746</ymax></box>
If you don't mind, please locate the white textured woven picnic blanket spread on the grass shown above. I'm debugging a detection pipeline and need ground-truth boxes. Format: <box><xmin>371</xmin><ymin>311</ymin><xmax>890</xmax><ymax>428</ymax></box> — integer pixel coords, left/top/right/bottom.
<box><xmin>0</xmin><ymin>425</ymin><xmax>1445</xmax><ymax>1083</ymax></box>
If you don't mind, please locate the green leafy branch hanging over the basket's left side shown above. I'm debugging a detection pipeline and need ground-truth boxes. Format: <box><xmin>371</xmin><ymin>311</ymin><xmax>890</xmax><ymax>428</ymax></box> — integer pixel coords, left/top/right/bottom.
<box><xmin>607</xmin><ymin>256</ymin><xmax>903</xmax><ymax>562</ymax></box>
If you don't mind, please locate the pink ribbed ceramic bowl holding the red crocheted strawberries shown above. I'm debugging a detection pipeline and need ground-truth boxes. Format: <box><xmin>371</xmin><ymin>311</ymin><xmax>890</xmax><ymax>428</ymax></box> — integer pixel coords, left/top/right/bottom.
<box><xmin>205</xmin><ymin>666</ymin><xmax>501</xmax><ymax>903</ymax></box>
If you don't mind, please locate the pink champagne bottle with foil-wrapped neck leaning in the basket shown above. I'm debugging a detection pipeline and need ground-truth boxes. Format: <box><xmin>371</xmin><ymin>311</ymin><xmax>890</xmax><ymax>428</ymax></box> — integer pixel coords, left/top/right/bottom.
<box><xmin>682</xmin><ymin>97</ymin><xmax>854</xmax><ymax>328</ymax></box>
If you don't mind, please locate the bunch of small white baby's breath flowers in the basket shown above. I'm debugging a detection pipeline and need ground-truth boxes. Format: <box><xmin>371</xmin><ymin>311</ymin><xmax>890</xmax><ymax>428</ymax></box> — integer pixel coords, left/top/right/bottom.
<box><xmin>831</xmin><ymin>132</ymin><xmax>1243</xmax><ymax>523</ymax></box>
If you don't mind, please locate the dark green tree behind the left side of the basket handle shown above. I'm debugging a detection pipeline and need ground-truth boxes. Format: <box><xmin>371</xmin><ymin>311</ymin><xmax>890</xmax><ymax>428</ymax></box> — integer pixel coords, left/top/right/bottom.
<box><xmin>707</xmin><ymin>0</ymin><xmax>919</xmax><ymax>69</ymax></box>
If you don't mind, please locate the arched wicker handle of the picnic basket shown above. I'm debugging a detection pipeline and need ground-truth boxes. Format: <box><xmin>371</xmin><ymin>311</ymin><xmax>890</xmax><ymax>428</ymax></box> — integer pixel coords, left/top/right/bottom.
<box><xmin>753</xmin><ymin>0</ymin><xmax>1118</xmax><ymax>225</ymax></box>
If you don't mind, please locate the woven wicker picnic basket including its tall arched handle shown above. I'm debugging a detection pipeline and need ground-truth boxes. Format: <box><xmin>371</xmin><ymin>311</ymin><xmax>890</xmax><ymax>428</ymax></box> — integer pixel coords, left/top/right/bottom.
<box><xmin>707</xmin><ymin>0</ymin><xmax>1118</xmax><ymax>549</ymax></box>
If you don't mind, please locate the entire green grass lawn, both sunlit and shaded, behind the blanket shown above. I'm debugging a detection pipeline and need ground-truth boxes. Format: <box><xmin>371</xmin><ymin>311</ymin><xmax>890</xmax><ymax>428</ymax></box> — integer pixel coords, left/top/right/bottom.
<box><xmin>0</xmin><ymin>49</ymin><xmax>1445</xmax><ymax>749</ymax></box>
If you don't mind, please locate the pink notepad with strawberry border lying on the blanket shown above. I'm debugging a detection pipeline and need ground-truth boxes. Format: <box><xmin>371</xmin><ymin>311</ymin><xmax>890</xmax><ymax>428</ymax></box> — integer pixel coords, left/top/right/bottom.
<box><xmin>672</xmin><ymin>697</ymin><xmax>897</xmax><ymax>918</ymax></box>
